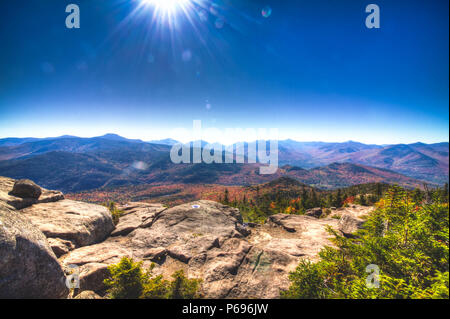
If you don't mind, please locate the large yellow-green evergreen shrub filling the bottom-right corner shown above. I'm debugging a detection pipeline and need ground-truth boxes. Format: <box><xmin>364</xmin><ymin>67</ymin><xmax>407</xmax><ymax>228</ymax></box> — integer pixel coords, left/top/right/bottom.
<box><xmin>282</xmin><ymin>186</ymin><xmax>449</xmax><ymax>299</ymax></box>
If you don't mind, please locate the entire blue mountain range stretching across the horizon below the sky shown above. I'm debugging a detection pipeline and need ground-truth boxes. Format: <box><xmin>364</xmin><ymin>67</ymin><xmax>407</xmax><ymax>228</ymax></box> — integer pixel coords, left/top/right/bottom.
<box><xmin>0</xmin><ymin>134</ymin><xmax>449</xmax><ymax>192</ymax></box>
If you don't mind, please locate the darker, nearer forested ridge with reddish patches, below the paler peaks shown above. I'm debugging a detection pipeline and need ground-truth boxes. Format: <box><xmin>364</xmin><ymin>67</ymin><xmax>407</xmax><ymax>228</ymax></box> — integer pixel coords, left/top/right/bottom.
<box><xmin>0</xmin><ymin>149</ymin><xmax>422</xmax><ymax>192</ymax></box>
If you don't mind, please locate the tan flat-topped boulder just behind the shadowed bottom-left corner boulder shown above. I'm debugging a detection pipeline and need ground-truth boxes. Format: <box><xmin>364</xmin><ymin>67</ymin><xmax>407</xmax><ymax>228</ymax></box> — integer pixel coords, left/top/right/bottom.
<box><xmin>21</xmin><ymin>199</ymin><xmax>114</xmax><ymax>248</ymax></box>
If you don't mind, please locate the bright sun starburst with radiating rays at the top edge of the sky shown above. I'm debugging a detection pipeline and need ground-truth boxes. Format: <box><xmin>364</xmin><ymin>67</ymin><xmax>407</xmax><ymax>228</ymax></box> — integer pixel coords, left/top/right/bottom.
<box><xmin>105</xmin><ymin>0</ymin><xmax>259</xmax><ymax>72</ymax></box>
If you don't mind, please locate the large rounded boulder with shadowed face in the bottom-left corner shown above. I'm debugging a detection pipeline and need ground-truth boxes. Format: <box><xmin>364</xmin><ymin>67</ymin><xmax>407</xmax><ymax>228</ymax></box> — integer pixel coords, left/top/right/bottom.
<box><xmin>0</xmin><ymin>202</ymin><xmax>68</xmax><ymax>298</ymax></box>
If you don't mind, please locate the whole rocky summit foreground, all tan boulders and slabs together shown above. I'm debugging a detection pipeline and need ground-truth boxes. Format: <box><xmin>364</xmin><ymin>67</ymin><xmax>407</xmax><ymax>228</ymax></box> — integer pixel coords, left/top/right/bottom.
<box><xmin>0</xmin><ymin>178</ymin><xmax>371</xmax><ymax>299</ymax></box>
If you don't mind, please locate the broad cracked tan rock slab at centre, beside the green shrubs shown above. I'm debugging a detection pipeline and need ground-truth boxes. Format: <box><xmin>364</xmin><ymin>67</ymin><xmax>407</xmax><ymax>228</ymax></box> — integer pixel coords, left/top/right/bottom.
<box><xmin>60</xmin><ymin>201</ymin><xmax>368</xmax><ymax>298</ymax></box>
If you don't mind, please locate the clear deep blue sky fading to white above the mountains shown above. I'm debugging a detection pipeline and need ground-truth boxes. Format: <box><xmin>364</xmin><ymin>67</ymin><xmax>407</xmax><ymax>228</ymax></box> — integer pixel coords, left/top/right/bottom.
<box><xmin>0</xmin><ymin>0</ymin><xmax>449</xmax><ymax>144</ymax></box>
